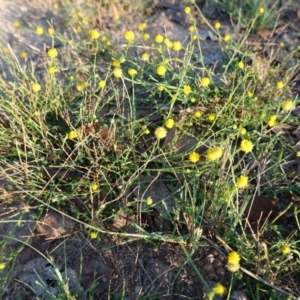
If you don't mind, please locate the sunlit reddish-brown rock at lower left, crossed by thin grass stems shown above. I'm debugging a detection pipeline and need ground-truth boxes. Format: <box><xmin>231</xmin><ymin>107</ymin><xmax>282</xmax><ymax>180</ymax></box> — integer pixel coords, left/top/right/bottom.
<box><xmin>36</xmin><ymin>211</ymin><xmax>76</xmax><ymax>239</ymax></box>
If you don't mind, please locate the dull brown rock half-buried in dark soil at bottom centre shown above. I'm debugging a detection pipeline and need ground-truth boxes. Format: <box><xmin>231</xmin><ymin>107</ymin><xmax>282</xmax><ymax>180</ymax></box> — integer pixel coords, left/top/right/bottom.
<box><xmin>143</xmin><ymin>258</ymin><xmax>173</xmax><ymax>299</ymax></box>
